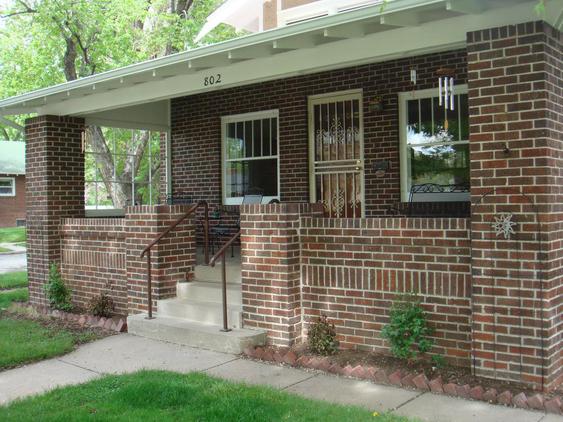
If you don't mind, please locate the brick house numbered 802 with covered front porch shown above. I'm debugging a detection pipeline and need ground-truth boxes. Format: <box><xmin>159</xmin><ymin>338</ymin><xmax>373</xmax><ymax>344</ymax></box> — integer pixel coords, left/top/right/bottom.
<box><xmin>0</xmin><ymin>0</ymin><xmax>563</xmax><ymax>390</ymax></box>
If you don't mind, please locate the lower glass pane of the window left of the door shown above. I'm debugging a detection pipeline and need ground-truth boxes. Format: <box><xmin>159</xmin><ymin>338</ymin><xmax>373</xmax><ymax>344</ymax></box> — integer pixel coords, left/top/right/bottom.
<box><xmin>225</xmin><ymin>159</ymin><xmax>278</xmax><ymax>198</ymax></box>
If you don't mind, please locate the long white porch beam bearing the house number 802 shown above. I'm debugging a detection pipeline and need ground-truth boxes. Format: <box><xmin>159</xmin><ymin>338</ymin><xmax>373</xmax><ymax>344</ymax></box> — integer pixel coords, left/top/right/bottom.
<box><xmin>38</xmin><ymin>3</ymin><xmax>534</xmax><ymax>115</ymax></box>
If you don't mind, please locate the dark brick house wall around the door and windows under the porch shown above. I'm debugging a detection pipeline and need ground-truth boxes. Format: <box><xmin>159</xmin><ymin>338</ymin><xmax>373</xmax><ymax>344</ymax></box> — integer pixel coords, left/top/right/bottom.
<box><xmin>171</xmin><ymin>50</ymin><xmax>466</xmax><ymax>217</ymax></box>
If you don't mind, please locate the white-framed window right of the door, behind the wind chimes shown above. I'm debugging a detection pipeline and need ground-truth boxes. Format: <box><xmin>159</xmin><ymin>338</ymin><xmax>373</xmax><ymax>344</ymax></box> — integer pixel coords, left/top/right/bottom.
<box><xmin>399</xmin><ymin>85</ymin><xmax>470</xmax><ymax>201</ymax></box>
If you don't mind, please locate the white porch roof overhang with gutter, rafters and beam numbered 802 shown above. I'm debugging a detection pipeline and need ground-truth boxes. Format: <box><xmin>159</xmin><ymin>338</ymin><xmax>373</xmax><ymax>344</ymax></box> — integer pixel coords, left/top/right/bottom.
<box><xmin>0</xmin><ymin>0</ymin><xmax>563</xmax><ymax>130</ymax></box>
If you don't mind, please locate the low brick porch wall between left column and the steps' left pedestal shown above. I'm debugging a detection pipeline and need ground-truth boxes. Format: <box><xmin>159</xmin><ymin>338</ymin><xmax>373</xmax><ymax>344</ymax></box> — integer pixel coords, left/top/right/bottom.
<box><xmin>61</xmin><ymin>218</ymin><xmax>127</xmax><ymax>315</ymax></box>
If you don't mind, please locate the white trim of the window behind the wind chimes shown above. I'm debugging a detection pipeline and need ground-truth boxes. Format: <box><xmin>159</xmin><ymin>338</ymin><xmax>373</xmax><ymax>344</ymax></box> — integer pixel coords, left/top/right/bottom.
<box><xmin>399</xmin><ymin>85</ymin><xmax>469</xmax><ymax>202</ymax></box>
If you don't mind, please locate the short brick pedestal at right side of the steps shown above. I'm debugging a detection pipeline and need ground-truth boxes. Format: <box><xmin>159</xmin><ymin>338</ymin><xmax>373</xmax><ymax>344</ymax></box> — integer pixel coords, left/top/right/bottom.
<box><xmin>241</xmin><ymin>203</ymin><xmax>322</xmax><ymax>346</ymax></box>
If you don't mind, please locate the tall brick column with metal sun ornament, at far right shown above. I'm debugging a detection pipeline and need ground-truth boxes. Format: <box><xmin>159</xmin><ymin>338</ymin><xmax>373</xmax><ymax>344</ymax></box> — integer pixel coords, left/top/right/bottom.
<box><xmin>467</xmin><ymin>22</ymin><xmax>563</xmax><ymax>390</ymax></box>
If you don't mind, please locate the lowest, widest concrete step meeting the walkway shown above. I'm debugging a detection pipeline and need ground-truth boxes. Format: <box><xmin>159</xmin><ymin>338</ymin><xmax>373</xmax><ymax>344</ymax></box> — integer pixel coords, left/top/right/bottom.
<box><xmin>127</xmin><ymin>314</ymin><xmax>266</xmax><ymax>354</ymax></box>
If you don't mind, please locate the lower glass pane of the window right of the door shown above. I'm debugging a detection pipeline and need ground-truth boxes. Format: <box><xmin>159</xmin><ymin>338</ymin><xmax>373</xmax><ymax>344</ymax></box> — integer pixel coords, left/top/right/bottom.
<box><xmin>408</xmin><ymin>144</ymin><xmax>469</xmax><ymax>185</ymax></box>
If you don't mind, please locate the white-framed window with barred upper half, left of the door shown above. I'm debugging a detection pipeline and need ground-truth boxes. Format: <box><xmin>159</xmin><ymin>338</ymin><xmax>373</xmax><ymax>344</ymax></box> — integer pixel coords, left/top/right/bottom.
<box><xmin>221</xmin><ymin>110</ymin><xmax>280</xmax><ymax>205</ymax></box>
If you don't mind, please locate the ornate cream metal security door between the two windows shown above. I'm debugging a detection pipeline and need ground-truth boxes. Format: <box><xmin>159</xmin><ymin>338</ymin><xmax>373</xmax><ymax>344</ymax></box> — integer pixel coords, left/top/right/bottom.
<box><xmin>309</xmin><ymin>91</ymin><xmax>364</xmax><ymax>218</ymax></box>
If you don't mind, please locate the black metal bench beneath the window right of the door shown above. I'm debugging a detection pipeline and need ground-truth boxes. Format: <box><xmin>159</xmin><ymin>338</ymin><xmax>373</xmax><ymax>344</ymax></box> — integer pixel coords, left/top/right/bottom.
<box><xmin>391</xmin><ymin>183</ymin><xmax>471</xmax><ymax>217</ymax></box>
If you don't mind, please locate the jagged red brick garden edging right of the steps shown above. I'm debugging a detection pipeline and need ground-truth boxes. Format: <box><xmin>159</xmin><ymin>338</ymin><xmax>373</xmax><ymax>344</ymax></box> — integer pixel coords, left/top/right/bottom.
<box><xmin>244</xmin><ymin>344</ymin><xmax>563</xmax><ymax>414</ymax></box>
